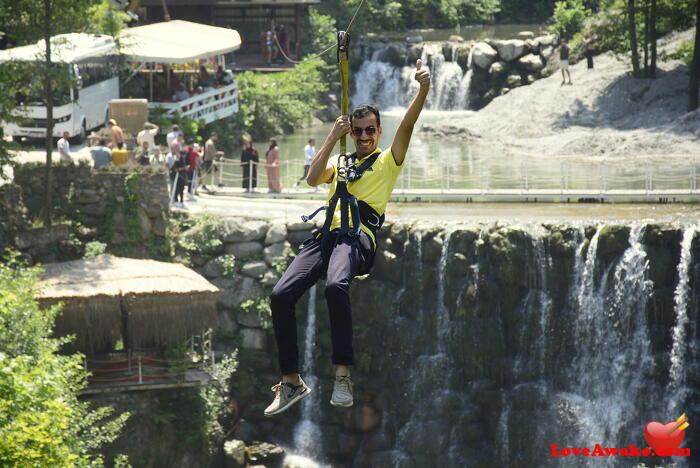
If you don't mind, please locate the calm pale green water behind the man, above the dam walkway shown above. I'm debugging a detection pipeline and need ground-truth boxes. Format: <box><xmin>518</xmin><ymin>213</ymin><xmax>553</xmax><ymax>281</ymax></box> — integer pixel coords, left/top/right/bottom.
<box><xmin>220</xmin><ymin>109</ymin><xmax>700</xmax><ymax>191</ymax></box>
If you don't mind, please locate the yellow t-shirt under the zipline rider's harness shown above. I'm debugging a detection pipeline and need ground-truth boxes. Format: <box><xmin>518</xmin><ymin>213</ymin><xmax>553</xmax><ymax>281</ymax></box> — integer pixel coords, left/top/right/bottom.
<box><xmin>326</xmin><ymin>148</ymin><xmax>403</xmax><ymax>243</ymax></box>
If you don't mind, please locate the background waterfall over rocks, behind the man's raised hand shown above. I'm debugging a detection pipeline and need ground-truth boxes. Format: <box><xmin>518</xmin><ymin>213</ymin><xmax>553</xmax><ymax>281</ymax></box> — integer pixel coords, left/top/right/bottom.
<box><xmin>352</xmin><ymin>44</ymin><xmax>473</xmax><ymax>110</ymax></box>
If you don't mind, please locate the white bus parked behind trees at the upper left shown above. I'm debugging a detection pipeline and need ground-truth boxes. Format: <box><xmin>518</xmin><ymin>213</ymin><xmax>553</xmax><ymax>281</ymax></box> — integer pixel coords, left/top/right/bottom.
<box><xmin>0</xmin><ymin>33</ymin><xmax>119</xmax><ymax>142</ymax></box>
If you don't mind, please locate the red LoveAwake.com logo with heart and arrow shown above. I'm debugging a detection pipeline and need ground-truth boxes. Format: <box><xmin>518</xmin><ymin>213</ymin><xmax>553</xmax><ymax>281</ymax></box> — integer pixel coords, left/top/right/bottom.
<box><xmin>550</xmin><ymin>413</ymin><xmax>690</xmax><ymax>457</ymax></box>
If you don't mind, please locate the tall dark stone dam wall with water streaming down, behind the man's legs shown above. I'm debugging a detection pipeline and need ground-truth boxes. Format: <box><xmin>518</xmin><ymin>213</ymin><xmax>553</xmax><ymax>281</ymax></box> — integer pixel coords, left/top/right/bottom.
<box><xmin>187</xmin><ymin>221</ymin><xmax>700</xmax><ymax>467</ymax></box>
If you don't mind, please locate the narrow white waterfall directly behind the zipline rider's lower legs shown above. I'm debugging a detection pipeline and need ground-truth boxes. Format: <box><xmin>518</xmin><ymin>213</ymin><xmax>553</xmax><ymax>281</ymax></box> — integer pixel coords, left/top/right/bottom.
<box><xmin>294</xmin><ymin>284</ymin><xmax>322</xmax><ymax>459</ymax></box>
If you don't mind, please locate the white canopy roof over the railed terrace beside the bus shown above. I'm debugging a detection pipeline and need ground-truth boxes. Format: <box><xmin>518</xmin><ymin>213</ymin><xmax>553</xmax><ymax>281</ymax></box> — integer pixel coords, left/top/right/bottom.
<box><xmin>119</xmin><ymin>20</ymin><xmax>241</xmax><ymax>63</ymax></box>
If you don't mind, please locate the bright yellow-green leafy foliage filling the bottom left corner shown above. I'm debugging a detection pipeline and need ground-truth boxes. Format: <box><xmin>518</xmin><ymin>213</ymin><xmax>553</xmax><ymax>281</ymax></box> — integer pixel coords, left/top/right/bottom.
<box><xmin>0</xmin><ymin>255</ymin><xmax>128</xmax><ymax>468</ymax></box>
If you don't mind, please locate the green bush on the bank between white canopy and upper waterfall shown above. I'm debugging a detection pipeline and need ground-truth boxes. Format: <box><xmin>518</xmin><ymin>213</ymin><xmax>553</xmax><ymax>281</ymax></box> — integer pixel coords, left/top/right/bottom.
<box><xmin>231</xmin><ymin>60</ymin><xmax>327</xmax><ymax>141</ymax></box>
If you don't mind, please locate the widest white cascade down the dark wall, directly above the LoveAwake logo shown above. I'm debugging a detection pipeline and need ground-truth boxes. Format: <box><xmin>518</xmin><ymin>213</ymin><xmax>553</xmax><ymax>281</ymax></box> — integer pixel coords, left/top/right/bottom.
<box><xmin>559</xmin><ymin>226</ymin><xmax>653</xmax><ymax>466</ymax></box>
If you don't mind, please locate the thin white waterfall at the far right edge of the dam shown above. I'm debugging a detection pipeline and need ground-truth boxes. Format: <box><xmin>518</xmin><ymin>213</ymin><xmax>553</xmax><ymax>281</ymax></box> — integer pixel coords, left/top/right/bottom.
<box><xmin>668</xmin><ymin>226</ymin><xmax>697</xmax><ymax>417</ymax></box>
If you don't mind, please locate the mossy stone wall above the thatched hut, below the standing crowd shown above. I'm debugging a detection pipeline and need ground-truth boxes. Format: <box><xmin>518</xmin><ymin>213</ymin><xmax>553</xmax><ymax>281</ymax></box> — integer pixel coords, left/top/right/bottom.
<box><xmin>5</xmin><ymin>164</ymin><xmax>168</xmax><ymax>262</ymax></box>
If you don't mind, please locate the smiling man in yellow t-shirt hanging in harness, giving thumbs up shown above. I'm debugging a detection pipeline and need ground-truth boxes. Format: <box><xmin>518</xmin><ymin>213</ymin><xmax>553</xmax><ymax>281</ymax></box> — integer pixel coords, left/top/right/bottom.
<box><xmin>265</xmin><ymin>60</ymin><xmax>430</xmax><ymax>416</ymax></box>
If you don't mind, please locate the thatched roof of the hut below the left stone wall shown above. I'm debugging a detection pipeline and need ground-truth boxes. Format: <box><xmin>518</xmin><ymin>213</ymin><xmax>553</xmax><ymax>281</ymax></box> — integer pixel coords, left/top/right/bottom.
<box><xmin>39</xmin><ymin>255</ymin><xmax>220</xmax><ymax>354</ymax></box>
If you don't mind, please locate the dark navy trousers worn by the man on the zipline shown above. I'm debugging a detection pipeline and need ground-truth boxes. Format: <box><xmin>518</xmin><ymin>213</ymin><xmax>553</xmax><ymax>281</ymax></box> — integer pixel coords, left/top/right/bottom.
<box><xmin>270</xmin><ymin>232</ymin><xmax>373</xmax><ymax>374</ymax></box>
